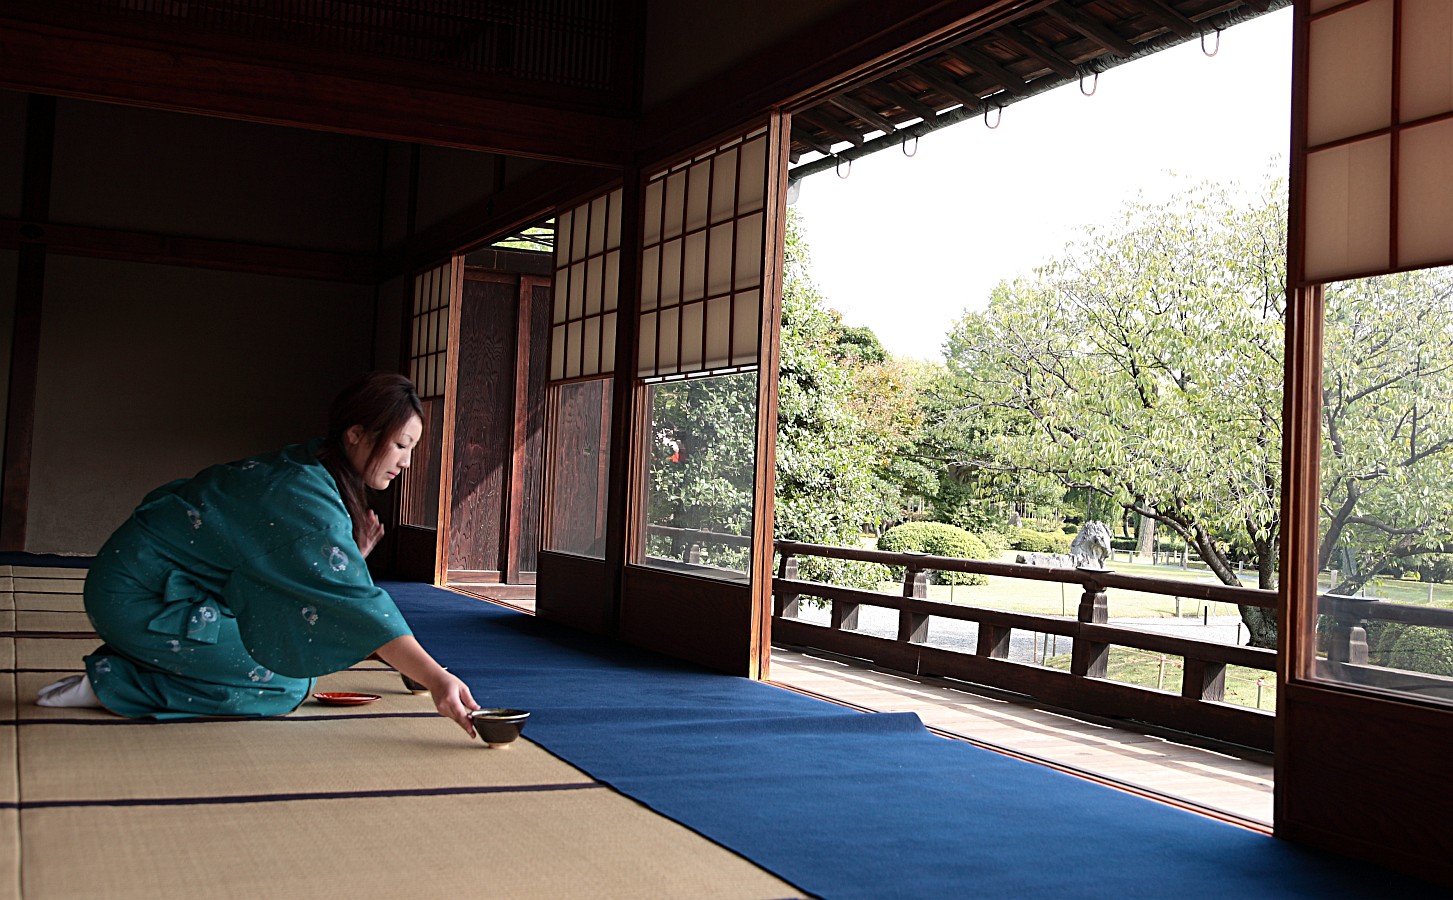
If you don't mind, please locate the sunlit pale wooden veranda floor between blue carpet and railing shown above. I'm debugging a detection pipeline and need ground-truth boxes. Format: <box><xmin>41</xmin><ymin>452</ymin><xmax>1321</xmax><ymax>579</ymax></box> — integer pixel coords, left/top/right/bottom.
<box><xmin>450</xmin><ymin>584</ymin><xmax>1271</xmax><ymax>829</ymax></box>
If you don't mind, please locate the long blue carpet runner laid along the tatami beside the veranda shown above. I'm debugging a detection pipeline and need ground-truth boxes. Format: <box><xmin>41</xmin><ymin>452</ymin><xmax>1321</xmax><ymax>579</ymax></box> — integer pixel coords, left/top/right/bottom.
<box><xmin>384</xmin><ymin>583</ymin><xmax>1447</xmax><ymax>900</ymax></box>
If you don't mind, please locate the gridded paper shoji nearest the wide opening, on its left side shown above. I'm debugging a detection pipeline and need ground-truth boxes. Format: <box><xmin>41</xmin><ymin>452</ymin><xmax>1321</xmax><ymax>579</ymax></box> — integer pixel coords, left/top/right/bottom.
<box><xmin>638</xmin><ymin>129</ymin><xmax>769</xmax><ymax>378</ymax></box>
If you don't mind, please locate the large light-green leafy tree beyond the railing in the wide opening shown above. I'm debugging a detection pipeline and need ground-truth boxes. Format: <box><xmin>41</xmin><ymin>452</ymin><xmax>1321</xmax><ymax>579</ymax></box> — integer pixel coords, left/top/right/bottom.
<box><xmin>940</xmin><ymin>183</ymin><xmax>1286</xmax><ymax>646</ymax></box>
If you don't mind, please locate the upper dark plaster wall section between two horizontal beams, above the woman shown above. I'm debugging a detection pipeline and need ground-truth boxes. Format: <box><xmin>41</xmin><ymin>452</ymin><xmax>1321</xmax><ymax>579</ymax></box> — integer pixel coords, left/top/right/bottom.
<box><xmin>51</xmin><ymin>100</ymin><xmax>386</xmax><ymax>253</ymax></box>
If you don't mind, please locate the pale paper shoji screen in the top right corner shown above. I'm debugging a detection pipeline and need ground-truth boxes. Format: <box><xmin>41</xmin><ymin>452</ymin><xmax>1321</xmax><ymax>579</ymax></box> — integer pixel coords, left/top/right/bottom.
<box><xmin>1293</xmin><ymin>0</ymin><xmax>1453</xmax><ymax>282</ymax></box>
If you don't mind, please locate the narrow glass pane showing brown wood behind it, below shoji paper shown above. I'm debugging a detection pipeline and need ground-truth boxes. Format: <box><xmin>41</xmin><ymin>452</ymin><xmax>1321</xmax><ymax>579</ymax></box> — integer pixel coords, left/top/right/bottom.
<box><xmin>545</xmin><ymin>378</ymin><xmax>612</xmax><ymax>560</ymax></box>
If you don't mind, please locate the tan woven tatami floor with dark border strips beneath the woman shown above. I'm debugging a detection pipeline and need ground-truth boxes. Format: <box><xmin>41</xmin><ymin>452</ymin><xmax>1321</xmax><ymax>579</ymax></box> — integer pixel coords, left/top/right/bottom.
<box><xmin>0</xmin><ymin>568</ymin><xmax>802</xmax><ymax>900</ymax></box>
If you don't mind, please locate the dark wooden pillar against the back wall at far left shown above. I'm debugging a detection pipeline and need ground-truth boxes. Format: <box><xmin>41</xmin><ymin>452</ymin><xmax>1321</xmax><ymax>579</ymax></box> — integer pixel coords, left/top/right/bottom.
<box><xmin>0</xmin><ymin>96</ymin><xmax>55</xmax><ymax>551</ymax></box>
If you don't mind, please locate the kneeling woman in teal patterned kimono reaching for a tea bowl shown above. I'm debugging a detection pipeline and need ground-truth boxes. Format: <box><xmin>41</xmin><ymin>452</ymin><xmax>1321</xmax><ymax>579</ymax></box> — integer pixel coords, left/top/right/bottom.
<box><xmin>36</xmin><ymin>372</ymin><xmax>478</xmax><ymax>736</ymax></box>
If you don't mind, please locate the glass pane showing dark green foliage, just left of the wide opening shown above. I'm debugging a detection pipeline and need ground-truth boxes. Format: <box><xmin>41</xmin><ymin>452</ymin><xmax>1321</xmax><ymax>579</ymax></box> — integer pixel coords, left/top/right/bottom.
<box><xmin>636</xmin><ymin>371</ymin><xmax>757</xmax><ymax>582</ymax></box>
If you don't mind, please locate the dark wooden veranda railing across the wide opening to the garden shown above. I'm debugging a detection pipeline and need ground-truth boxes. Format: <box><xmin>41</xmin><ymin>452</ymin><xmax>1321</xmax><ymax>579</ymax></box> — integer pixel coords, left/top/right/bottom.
<box><xmin>773</xmin><ymin>541</ymin><xmax>1277</xmax><ymax>750</ymax></box>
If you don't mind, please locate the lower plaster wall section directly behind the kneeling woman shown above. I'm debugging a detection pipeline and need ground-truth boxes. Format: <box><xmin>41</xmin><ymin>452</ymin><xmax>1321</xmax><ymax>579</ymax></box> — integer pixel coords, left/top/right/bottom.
<box><xmin>26</xmin><ymin>251</ymin><xmax>373</xmax><ymax>554</ymax></box>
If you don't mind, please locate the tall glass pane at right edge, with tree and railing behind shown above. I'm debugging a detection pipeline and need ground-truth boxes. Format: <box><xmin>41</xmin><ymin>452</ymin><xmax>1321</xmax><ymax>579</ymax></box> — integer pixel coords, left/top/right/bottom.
<box><xmin>1315</xmin><ymin>269</ymin><xmax>1453</xmax><ymax>702</ymax></box>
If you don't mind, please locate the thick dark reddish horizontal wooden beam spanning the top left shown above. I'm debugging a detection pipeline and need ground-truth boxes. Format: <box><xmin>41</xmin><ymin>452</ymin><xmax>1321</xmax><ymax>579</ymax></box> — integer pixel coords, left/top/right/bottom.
<box><xmin>0</xmin><ymin>16</ymin><xmax>631</xmax><ymax>166</ymax></box>
